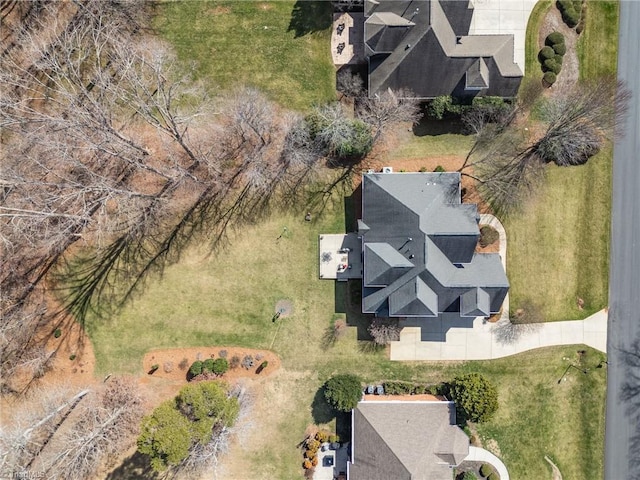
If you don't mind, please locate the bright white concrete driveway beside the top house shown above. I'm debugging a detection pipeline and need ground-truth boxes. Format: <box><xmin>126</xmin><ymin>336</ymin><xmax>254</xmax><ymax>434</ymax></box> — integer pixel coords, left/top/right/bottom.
<box><xmin>469</xmin><ymin>0</ymin><xmax>538</xmax><ymax>73</ymax></box>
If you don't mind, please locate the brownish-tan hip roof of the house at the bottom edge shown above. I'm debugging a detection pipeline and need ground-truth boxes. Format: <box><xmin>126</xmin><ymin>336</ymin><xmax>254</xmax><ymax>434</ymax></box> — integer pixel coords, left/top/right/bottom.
<box><xmin>348</xmin><ymin>402</ymin><xmax>469</xmax><ymax>480</ymax></box>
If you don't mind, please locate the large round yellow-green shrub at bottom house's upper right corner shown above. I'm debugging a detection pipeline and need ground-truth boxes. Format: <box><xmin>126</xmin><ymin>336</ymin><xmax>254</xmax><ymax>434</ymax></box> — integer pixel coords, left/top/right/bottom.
<box><xmin>449</xmin><ymin>373</ymin><xmax>498</xmax><ymax>422</ymax></box>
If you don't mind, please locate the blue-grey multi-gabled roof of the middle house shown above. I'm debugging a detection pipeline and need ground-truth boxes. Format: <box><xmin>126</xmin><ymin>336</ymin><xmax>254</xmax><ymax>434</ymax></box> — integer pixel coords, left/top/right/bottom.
<box><xmin>358</xmin><ymin>173</ymin><xmax>509</xmax><ymax>317</ymax></box>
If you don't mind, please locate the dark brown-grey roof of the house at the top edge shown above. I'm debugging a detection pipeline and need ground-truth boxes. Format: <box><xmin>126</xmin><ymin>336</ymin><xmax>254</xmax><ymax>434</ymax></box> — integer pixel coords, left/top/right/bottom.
<box><xmin>364</xmin><ymin>0</ymin><xmax>522</xmax><ymax>98</ymax></box>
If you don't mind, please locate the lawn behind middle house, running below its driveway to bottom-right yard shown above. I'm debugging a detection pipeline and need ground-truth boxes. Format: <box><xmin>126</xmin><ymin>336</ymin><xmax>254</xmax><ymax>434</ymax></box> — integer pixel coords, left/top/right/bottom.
<box><xmin>88</xmin><ymin>182</ymin><xmax>606</xmax><ymax>480</ymax></box>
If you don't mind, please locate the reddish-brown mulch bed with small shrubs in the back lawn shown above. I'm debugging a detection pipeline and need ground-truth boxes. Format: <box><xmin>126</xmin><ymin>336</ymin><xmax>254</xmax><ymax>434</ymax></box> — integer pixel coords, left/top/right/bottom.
<box><xmin>142</xmin><ymin>346</ymin><xmax>280</xmax><ymax>384</ymax></box>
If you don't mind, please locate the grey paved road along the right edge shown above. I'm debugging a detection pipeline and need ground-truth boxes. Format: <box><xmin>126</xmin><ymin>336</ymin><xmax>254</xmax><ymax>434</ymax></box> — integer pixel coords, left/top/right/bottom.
<box><xmin>605</xmin><ymin>0</ymin><xmax>640</xmax><ymax>480</ymax></box>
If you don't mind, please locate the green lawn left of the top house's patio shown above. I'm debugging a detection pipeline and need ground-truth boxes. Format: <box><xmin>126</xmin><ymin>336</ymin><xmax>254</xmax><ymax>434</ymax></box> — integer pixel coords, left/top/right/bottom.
<box><xmin>154</xmin><ymin>0</ymin><xmax>335</xmax><ymax>111</ymax></box>
